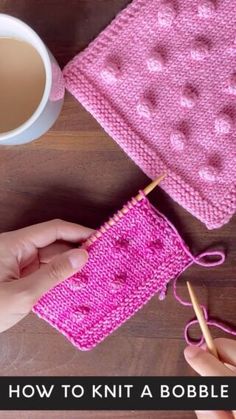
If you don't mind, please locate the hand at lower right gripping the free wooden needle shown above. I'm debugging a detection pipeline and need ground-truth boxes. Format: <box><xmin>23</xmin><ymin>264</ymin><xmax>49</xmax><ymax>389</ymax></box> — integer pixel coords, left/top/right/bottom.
<box><xmin>184</xmin><ymin>339</ymin><xmax>236</xmax><ymax>419</ymax></box>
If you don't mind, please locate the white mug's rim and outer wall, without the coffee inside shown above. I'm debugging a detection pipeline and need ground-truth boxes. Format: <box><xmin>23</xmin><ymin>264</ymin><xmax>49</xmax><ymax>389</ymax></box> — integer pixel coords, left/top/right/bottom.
<box><xmin>0</xmin><ymin>13</ymin><xmax>65</xmax><ymax>145</ymax></box>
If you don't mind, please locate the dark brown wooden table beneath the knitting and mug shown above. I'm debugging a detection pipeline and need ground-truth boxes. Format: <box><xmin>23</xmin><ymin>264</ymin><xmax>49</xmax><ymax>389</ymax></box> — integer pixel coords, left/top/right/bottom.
<box><xmin>0</xmin><ymin>0</ymin><xmax>236</xmax><ymax>419</ymax></box>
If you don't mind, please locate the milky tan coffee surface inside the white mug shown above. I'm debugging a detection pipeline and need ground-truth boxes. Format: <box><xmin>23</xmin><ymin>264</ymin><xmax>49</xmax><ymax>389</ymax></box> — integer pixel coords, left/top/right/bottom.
<box><xmin>0</xmin><ymin>38</ymin><xmax>46</xmax><ymax>133</ymax></box>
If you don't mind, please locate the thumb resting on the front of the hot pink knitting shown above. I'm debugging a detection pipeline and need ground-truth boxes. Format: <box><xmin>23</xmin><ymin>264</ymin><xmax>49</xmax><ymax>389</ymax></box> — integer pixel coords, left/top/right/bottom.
<box><xmin>15</xmin><ymin>249</ymin><xmax>88</xmax><ymax>305</ymax></box>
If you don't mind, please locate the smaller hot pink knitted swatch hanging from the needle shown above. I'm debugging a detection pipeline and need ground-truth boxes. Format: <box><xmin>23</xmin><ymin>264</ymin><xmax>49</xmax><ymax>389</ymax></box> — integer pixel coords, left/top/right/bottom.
<box><xmin>33</xmin><ymin>198</ymin><xmax>227</xmax><ymax>350</ymax></box>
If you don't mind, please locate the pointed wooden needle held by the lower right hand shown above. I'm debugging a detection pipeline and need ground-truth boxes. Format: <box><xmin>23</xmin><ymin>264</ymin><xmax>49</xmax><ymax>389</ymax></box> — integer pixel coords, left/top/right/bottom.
<box><xmin>187</xmin><ymin>282</ymin><xmax>219</xmax><ymax>359</ymax></box>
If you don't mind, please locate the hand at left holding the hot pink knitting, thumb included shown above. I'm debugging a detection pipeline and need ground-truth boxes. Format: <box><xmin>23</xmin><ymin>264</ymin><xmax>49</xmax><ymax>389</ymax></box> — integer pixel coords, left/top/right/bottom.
<box><xmin>0</xmin><ymin>220</ymin><xmax>93</xmax><ymax>332</ymax></box>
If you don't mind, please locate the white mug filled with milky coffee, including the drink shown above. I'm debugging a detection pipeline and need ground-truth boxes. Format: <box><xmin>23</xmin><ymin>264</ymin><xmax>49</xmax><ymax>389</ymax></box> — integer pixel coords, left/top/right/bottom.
<box><xmin>0</xmin><ymin>13</ymin><xmax>65</xmax><ymax>145</ymax></box>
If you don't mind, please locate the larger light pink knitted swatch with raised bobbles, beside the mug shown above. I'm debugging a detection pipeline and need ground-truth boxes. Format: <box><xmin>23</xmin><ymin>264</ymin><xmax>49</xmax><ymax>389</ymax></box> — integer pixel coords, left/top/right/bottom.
<box><xmin>64</xmin><ymin>0</ymin><xmax>236</xmax><ymax>228</ymax></box>
